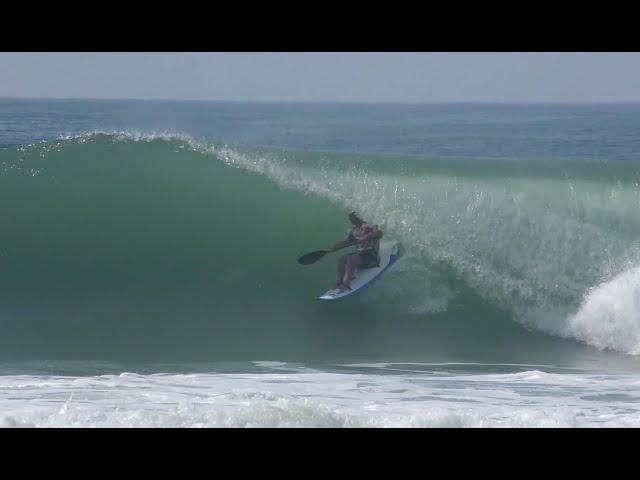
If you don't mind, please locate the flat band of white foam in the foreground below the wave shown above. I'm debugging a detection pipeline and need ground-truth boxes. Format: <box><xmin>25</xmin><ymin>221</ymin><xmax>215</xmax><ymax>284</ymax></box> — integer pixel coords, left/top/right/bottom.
<box><xmin>0</xmin><ymin>370</ymin><xmax>640</xmax><ymax>427</ymax></box>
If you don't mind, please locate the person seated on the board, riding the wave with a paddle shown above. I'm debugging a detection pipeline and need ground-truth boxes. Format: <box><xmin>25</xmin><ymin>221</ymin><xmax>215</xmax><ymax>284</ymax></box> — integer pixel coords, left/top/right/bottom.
<box><xmin>331</xmin><ymin>212</ymin><xmax>382</xmax><ymax>292</ymax></box>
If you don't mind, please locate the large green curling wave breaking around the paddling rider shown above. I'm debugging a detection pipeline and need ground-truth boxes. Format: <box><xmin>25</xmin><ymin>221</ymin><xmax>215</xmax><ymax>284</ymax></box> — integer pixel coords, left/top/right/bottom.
<box><xmin>0</xmin><ymin>133</ymin><xmax>640</xmax><ymax>361</ymax></box>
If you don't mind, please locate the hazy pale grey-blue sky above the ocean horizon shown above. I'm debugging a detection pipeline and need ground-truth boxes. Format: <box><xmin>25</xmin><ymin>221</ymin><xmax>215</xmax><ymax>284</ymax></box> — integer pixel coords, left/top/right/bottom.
<box><xmin>0</xmin><ymin>52</ymin><xmax>640</xmax><ymax>102</ymax></box>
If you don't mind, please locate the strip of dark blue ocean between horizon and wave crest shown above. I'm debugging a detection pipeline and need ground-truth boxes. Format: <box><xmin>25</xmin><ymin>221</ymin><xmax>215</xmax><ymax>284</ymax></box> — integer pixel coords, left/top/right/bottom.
<box><xmin>0</xmin><ymin>99</ymin><xmax>640</xmax><ymax>161</ymax></box>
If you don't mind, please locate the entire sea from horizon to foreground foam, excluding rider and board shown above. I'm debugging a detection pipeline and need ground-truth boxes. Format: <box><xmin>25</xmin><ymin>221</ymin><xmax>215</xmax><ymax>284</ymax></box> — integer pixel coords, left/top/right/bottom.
<box><xmin>0</xmin><ymin>99</ymin><xmax>640</xmax><ymax>427</ymax></box>
